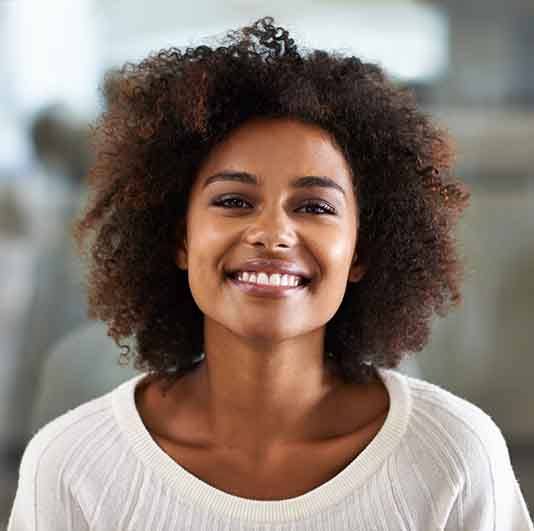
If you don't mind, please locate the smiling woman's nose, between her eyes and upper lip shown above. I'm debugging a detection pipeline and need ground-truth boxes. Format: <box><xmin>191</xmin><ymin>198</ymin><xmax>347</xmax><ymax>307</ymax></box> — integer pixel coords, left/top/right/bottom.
<box><xmin>245</xmin><ymin>207</ymin><xmax>297</xmax><ymax>249</ymax></box>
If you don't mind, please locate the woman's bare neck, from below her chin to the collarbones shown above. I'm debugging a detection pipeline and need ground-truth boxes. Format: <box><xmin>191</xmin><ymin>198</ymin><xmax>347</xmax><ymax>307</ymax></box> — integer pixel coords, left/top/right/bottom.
<box><xmin>180</xmin><ymin>318</ymin><xmax>343</xmax><ymax>452</ymax></box>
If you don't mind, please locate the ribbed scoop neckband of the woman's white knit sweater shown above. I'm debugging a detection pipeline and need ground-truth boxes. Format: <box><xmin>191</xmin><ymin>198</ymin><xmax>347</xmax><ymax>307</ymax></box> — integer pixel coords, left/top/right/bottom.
<box><xmin>111</xmin><ymin>367</ymin><xmax>412</xmax><ymax>523</ymax></box>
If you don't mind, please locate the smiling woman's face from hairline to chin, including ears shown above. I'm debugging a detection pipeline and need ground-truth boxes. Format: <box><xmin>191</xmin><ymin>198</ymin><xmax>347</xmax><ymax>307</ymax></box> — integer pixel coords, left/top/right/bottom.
<box><xmin>176</xmin><ymin>119</ymin><xmax>364</xmax><ymax>342</ymax></box>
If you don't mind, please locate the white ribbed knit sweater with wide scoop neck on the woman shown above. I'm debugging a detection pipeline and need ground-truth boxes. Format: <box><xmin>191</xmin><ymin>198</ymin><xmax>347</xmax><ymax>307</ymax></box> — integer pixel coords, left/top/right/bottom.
<box><xmin>8</xmin><ymin>369</ymin><xmax>534</xmax><ymax>531</ymax></box>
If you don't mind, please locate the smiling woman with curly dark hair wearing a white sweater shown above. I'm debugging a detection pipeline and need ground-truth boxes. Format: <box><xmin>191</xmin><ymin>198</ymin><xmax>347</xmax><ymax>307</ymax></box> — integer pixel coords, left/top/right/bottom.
<box><xmin>9</xmin><ymin>17</ymin><xmax>532</xmax><ymax>531</ymax></box>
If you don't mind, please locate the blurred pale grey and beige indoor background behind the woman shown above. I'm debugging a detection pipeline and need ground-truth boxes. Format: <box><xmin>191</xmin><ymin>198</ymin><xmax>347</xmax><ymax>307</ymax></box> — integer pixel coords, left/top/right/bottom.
<box><xmin>0</xmin><ymin>0</ymin><xmax>534</xmax><ymax>528</ymax></box>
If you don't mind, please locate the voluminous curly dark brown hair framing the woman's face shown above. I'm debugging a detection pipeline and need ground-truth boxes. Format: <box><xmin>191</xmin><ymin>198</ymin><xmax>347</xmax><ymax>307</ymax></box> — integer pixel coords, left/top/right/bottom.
<box><xmin>74</xmin><ymin>17</ymin><xmax>470</xmax><ymax>390</ymax></box>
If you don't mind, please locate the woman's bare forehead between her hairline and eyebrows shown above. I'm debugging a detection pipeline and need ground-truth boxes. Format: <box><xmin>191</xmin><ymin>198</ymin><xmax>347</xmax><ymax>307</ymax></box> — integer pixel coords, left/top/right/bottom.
<box><xmin>200</xmin><ymin>118</ymin><xmax>351</xmax><ymax>181</ymax></box>
